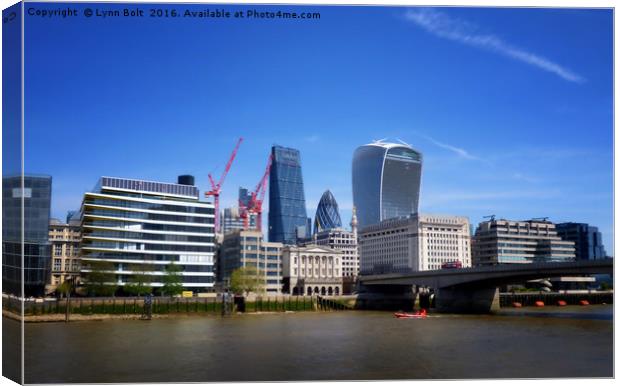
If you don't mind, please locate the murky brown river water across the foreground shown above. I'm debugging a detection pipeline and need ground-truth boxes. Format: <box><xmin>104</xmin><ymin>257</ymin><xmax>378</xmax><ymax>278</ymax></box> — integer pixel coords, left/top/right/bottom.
<box><xmin>4</xmin><ymin>306</ymin><xmax>613</xmax><ymax>383</ymax></box>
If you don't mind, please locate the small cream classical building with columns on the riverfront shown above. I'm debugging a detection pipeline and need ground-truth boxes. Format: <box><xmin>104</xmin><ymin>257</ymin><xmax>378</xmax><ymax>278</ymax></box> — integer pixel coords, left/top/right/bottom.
<box><xmin>282</xmin><ymin>245</ymin><xmax>344</xmax><ymax>296</ymax></box>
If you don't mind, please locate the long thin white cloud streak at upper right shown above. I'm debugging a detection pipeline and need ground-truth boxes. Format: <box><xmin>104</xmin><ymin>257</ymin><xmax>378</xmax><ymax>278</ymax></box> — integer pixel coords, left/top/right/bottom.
<box><xmin>405</xmin><ymin>8</ymin><xmax>585</xmax><ymax>83</ymax></box>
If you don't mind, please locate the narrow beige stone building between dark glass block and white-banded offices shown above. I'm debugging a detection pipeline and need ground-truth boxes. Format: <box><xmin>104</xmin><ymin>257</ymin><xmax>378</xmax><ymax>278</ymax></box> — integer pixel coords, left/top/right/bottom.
<box><xmin>49</xmin><ymin>216</ymin><xmax>82</xmax><ymax>292</ymax></box>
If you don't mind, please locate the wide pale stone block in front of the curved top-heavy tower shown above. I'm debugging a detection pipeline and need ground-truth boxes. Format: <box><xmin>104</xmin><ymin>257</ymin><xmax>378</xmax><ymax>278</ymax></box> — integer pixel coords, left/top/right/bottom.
<box><xmin>358</xmin><ymin>214</ymin><xmax>472</xmax><ymax>274</ymax></box>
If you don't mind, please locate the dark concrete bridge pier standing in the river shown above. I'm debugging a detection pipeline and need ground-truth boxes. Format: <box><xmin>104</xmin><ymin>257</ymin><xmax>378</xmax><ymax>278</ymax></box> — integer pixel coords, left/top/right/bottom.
<box><xmin>435</xmin><ymin>286</ymin><xmax>499</xmax><ymax>314</ymax></box>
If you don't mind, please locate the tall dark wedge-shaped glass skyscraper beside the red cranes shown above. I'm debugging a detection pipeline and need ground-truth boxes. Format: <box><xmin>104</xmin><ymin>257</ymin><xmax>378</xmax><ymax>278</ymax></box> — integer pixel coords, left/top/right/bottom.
<box><xmin>269</xmin><ymin>146</ymin><xmax>310</xmax><ymax>244</ymax></box>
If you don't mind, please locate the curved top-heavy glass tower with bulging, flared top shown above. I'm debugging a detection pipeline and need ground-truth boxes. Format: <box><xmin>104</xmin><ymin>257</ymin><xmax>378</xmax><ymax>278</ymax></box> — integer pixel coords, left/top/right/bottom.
<box><xmin>352</xmin><ymin>141</ymin><xmax>422</xmax><ymax>229</ymax></box>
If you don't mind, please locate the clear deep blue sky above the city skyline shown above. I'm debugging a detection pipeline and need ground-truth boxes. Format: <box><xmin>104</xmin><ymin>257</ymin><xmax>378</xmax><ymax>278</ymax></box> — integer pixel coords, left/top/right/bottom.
<box><xmin>18</xmin><ymin>3</ymin><xmax>613</xmax><ymax>254</ymax></box>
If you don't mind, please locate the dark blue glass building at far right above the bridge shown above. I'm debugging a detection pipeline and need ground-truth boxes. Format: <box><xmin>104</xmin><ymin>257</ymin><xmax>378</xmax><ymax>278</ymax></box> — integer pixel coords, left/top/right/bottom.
<box><xmin>555</xmin><ymin>222</ymin><xmax>607</xmax><ymax>260</ymax></box>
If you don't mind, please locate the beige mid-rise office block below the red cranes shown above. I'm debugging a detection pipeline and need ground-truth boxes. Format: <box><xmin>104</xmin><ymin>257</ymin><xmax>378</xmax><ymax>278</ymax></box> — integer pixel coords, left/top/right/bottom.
<box><xmin>218</xmin><ymin>230</ymin><xmax>283</xmax><ymax>294</ymax></box>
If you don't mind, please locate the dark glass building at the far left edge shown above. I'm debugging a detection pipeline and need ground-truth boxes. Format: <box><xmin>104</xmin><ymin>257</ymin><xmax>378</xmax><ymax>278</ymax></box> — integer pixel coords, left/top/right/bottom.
<box><xmin>2</xmin><ymin>175</ymin><xmax>52</xmax><ymax>297</ymax></box>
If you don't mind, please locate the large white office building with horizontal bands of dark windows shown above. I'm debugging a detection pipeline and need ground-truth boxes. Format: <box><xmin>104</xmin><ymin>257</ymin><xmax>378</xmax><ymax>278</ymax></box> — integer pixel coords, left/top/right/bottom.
<box><xmin>81</xmin><ymin>177</ymin><xmax>215</xmax><ymax>292</ymax></box>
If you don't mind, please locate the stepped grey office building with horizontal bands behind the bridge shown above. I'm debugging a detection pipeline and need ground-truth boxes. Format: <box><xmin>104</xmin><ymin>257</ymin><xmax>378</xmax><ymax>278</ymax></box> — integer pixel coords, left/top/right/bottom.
<box><xmin>473</xmin><ymin>219</ymin><xmax>575</xmax><ymax>265</ymax></box>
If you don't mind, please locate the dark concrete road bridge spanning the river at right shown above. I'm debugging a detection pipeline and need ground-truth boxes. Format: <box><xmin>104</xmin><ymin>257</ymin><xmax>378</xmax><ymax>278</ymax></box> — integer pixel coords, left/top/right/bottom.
<box><xmin>360</xmin><ymin>259</ymin><xmax>613</xmax><ymax>313</ymax></box>
